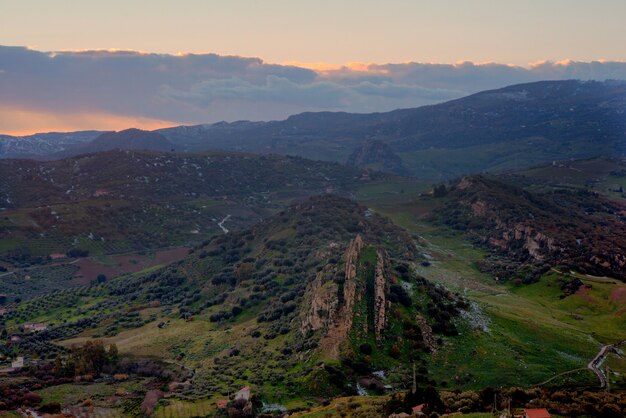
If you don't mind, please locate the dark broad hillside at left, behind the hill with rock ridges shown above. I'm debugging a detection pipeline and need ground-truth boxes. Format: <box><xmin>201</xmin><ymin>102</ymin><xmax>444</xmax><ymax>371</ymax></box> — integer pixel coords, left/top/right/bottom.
<box><xmin>0</xmin><ymin>150</ymin><xmax>384</xmax><ymax>298</ymax></box>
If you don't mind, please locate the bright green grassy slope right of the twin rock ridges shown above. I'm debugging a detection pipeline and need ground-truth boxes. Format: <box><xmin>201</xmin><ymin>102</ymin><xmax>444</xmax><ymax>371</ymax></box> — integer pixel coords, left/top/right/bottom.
<box><xmin>371</xmin><ymin>189</ymin><xmax>626</xmax><ymax>388</ymax></box>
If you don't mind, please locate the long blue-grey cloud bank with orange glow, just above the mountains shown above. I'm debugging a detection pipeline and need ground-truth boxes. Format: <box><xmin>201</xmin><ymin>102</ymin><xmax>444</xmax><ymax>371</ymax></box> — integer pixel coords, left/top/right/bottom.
<box><xmin>0</xmin><ymin>46</ymin><xmax>626</xmax><ymax>133</ymax></box>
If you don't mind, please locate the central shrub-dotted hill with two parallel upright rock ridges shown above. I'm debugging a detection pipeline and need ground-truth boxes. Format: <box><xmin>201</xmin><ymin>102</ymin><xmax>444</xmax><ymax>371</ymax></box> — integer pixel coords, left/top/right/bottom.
<box><xmin>4</xmin><ymin>195</ymin><xmax>466</xmax><ymax>400</ymax></box>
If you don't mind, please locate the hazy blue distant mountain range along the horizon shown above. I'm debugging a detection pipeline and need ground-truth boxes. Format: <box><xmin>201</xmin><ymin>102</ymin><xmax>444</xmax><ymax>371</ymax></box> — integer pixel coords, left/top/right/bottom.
<box><xmin>0</xmin><ymin>80</ymin><xmax>626</xmax><ymax>179</ymax></box>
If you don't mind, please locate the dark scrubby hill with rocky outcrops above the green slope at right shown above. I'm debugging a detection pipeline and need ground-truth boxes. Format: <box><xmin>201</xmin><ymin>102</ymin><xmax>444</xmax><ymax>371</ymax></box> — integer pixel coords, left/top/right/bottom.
<box><xmin>436</xmin><ymin>176</ymin><xmax>626</xmax><ymax>282</ymax></box>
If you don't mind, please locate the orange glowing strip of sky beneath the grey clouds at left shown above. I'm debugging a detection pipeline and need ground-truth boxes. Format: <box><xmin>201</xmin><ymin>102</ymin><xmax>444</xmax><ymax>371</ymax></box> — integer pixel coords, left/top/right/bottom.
<box><xmin>0</xmin><ymin>106</ymin><xmax>180</xmax><ymax>136</ymax></box>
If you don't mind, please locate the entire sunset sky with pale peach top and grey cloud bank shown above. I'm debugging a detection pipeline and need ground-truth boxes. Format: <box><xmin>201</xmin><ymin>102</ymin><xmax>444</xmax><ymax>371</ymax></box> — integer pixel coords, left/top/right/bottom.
<box><xmin>0</xmin><ymin>0</ymin><xmax>626</xmax><ymax>134</ymax></box>
